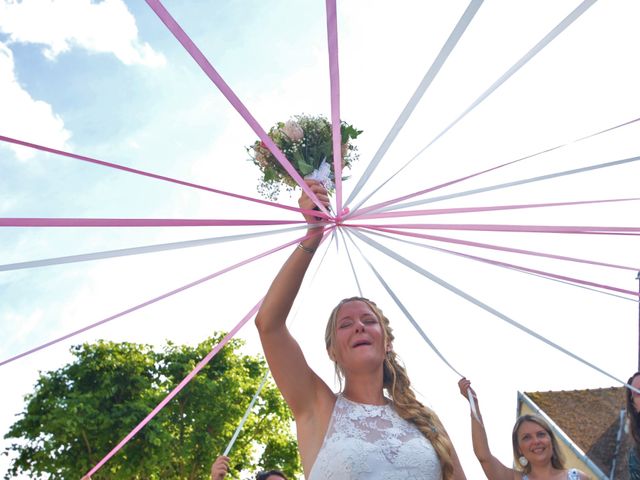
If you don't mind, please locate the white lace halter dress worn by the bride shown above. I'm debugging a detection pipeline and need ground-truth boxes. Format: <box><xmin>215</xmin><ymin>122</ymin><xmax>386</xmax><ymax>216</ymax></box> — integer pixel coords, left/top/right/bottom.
<box><xmin>308</xmin><ymin>395</ymin><xmax>442</xmax><ymax>480</ymax></box>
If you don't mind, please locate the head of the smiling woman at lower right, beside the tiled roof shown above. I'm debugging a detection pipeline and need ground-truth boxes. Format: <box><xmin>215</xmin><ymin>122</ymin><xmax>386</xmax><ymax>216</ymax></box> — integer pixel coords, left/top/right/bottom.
<box><xmin>511</xmin><ymin>415</ymin><xmax>564</xmax><ymax>474</ymax></box>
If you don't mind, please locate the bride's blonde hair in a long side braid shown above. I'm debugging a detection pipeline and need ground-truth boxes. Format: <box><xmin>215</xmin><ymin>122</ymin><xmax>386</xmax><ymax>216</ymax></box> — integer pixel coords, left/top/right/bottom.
<box><xmin>324</xmin><ymin>297</ymin><xmax>453</xmax><ymax>480</ymax></box>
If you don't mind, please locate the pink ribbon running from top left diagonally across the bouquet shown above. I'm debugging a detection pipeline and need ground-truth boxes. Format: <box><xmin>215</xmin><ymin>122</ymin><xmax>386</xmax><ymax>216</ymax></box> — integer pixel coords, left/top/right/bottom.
<box><xmin>146</xmin><ymin>0</ymin><xmax>329</xmax><ymax>215</ymax></box>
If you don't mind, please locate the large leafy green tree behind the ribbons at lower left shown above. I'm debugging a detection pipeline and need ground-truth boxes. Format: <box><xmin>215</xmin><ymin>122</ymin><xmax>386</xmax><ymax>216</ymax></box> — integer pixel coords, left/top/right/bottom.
<box><xmin>5</xmin><ymin>334</ymin><xmax>301</xmax><ymax>480</ymax></box>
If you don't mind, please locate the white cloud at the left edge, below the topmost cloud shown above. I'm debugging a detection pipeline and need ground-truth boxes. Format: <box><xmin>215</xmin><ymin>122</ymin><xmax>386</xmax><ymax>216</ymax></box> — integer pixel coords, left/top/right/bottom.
<box><xmin>0</xmin><ymin>41</ymin><xmax>71</xmax><ymax>160</ymax></box>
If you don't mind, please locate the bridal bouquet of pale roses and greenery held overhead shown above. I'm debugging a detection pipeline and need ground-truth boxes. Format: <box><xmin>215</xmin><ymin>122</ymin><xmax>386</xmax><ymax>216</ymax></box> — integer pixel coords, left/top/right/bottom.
<box><xmin>247</xmin><ymin>115</ymin><xmax>362</xmax><ymax>200</ymax></box>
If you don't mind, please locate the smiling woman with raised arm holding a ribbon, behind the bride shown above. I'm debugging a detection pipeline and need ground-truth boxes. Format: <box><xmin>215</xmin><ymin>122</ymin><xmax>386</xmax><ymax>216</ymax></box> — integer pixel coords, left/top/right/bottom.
<box><xmin>458</xmin><ymin>378</ymin><xmax>589</xmax><ymax>480</ymax></box>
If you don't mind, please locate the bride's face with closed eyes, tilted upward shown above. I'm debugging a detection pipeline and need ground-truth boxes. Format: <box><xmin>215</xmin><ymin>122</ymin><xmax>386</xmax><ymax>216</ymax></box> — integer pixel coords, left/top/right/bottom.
<box><xmin>327</xmin><ymin>299</ymin><xmax>388</xmax><ymax>374</ymax></box>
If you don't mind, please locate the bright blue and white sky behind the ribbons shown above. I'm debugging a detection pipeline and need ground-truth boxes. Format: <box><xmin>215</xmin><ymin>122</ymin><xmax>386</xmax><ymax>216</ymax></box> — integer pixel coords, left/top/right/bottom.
<box><xmin>0</xmin><ymin>0</ymin><xmax>640</xmax><ymax>478</ymax></box>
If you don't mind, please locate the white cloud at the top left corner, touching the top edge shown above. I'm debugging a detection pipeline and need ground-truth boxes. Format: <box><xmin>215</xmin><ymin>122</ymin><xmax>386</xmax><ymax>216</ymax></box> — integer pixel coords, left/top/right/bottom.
<box><xmin>0</xmin><ymin>0</ymin><xmax>165</xmax><ymax>67</ymax></box>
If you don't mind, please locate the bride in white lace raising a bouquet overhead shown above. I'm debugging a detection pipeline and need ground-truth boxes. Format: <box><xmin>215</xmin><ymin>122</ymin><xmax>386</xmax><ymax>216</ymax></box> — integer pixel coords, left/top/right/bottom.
<box><xmin>256</xmin><ymin>180</ymin><xmax>466</xmax><ymax>480</ymax></box>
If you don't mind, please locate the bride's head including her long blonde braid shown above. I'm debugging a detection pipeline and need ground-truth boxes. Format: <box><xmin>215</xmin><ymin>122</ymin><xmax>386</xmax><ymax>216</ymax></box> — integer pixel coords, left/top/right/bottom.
<box><xmin>325</xmin><ymin>297</ymin><xmax>453</xmax><ymax>480</ymax></box>
